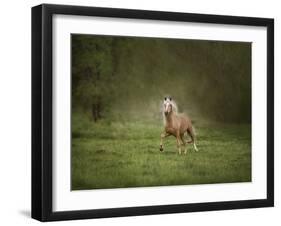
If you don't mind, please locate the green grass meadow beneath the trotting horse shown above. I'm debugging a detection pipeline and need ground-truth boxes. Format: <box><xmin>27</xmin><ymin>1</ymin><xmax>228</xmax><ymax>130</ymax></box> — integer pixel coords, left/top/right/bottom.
<box><xmin>71</xmin><ymin>121</ymin><xmax>251</xmax><ymax>190</ymax></box>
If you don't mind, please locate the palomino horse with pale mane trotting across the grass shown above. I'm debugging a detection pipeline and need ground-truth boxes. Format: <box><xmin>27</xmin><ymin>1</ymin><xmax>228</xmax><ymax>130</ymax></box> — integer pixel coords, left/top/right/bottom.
<box><xmin>160</xmin><ymin>97</ymin><xmax>198</xmax><ymax>154</ymax></box>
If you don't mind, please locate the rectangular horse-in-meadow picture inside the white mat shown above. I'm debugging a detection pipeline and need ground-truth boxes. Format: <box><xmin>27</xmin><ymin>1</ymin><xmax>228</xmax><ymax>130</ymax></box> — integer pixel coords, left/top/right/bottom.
<box><xmin>71</xmin><ymin>34</ymin><xmax>252</xmax><ymax>190</ymax></box>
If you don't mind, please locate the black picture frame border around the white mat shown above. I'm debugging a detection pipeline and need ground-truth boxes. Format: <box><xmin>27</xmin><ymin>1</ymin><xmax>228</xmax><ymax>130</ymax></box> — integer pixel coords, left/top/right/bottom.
<box><xmin>32</xmin><ymin>4</ymin><xmax>274</xmax><ymax>221</ymax></box>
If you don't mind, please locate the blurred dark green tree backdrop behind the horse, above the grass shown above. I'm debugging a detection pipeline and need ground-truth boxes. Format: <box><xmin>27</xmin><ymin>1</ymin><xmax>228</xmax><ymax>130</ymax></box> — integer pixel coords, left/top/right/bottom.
<box><xmin>72</xmin><ymin>35</ymin><xmax>251</xmax><ymax>123</ymax></box>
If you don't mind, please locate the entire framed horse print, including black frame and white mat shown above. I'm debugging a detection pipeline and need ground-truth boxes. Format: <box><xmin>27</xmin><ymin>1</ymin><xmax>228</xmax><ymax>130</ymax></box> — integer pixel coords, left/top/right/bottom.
<box><xmin>31</xmin><ymin>4</ymin><xmax>274</xmax><ymax>221</ymax></box>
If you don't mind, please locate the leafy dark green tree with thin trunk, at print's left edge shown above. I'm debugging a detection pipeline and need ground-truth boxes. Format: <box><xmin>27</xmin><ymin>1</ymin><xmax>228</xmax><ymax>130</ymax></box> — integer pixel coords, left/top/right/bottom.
<box><xmin>72</xmin><ymin>35</ymin><xmax>114</xmax><ymax>121</ymax></box>
